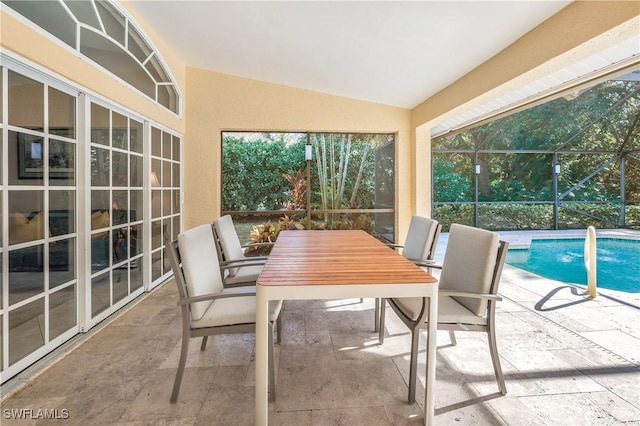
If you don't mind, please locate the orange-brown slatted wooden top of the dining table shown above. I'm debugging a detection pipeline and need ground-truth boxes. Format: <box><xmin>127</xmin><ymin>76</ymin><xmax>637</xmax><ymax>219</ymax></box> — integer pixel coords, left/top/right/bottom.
<box><xmin>258</xmin><ymin>231</ymin><xmax>436</xmax><ymax>286</ymax></box>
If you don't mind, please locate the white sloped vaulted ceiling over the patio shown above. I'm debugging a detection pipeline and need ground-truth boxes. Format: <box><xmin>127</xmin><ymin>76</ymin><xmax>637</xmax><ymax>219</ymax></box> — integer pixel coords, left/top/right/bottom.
<box><xmin>126</xmin><ymin>0</ymin><xmax>570</xmax><ymax>108</ymax></box>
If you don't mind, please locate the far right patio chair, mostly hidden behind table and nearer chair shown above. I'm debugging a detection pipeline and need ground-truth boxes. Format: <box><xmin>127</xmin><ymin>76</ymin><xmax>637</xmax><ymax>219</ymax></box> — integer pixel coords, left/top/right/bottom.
<box><xmin>374</xmin><ymin>216</ymin><xmax>442</xmax><ymax>331</ymax></box>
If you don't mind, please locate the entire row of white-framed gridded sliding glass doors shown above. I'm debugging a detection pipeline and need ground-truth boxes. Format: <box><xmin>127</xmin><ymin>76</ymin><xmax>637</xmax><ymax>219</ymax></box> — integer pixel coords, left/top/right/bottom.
<box><xmin>0</xmin><ymin>62</ymin><xmax>182</xmax><ymax>382</ymax></box>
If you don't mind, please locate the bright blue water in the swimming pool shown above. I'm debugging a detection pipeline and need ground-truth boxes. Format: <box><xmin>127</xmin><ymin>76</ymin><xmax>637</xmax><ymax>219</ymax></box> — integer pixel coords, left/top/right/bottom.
<box><xmin>506</xmin><ymin>237</ymin><xmax>640</xmax><ymax>293</ymax></box>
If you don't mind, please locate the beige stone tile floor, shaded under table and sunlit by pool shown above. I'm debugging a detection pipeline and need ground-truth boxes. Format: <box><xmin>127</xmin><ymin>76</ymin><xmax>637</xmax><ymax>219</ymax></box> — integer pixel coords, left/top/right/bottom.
<box><xmin>0</xmin><ymin>231</ymin><xmax>640</xmax><ymax>426</ymax></box>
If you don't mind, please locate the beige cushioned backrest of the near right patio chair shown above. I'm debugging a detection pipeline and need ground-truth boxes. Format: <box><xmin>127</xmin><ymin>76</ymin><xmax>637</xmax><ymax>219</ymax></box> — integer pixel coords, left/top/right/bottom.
<box><xmin>440</xmin><ymin>224</ymin><xmax>506</xmax><ymax>316</ymax></box>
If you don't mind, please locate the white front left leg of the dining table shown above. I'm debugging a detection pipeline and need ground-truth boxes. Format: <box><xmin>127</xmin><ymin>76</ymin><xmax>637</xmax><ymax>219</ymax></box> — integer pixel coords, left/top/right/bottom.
<box><xmin>255</xmin><ymin>286</ymin><xmax>269</xmax><ymax>426</ymax></box>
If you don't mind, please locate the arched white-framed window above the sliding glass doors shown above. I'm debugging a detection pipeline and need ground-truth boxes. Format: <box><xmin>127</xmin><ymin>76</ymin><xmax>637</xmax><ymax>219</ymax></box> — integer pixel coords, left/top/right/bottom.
<box><xmin>2</xmin><ymin>0</ymin><xmax>181</xmax><ymax>114</ymax></box>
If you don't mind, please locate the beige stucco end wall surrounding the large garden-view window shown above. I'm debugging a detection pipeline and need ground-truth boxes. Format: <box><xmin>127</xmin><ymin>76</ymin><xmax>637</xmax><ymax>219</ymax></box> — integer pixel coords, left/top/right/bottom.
<box><xmin>184</xmin><ymin>68</ymin><xmax>412</xmax><ymax>235</ymax></box>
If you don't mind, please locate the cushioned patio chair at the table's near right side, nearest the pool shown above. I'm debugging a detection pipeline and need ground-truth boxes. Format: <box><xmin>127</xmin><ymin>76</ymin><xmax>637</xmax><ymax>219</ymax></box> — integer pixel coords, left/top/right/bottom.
<box><xmin>380</xmin><ymin>224</ymin><xmax>509</xmax><ymax>403</ymax></box>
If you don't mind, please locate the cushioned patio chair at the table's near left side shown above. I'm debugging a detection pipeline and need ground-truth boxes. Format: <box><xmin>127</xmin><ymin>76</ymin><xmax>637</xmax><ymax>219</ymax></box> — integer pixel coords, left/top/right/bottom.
<box><xmin>167</xmin><ymin>225</ymin><xmax>282</xmax><ymax>403</ymax></box>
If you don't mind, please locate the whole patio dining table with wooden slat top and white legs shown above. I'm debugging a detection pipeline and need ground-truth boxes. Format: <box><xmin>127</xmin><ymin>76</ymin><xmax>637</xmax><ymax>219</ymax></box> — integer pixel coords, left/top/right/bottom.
<box><xmin>255</xmin><ymin>230</ymin><xmax>438</xmax><ymax>425</ymax></box>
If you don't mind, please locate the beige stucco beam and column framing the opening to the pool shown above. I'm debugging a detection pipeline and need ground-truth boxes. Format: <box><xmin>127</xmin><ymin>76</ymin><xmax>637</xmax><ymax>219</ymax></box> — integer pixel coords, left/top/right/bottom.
<box><xmin>411</xmin><ymin>0</ymin><xmax>640</xmax><ymax>214</ymax></box>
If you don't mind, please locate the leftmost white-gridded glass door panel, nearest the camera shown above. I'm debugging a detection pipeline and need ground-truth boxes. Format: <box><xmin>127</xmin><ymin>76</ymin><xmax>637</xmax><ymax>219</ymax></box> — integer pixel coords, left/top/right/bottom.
<box><xmin>0</xmin><ymin>68</ymin><xmax>78</xmax><ymax>377</ymax></box>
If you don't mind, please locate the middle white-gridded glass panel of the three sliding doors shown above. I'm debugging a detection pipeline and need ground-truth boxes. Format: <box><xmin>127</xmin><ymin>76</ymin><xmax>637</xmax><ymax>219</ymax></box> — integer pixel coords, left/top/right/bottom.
<box><xmin>89</xmin><ymin>103</ymin><xmax>144</xmax><ymax>319</ymax></box>
